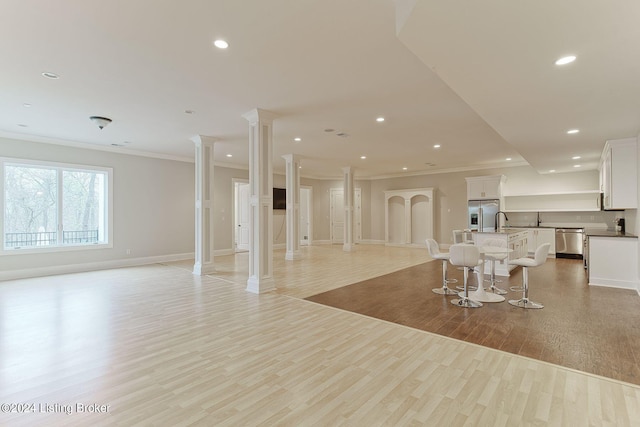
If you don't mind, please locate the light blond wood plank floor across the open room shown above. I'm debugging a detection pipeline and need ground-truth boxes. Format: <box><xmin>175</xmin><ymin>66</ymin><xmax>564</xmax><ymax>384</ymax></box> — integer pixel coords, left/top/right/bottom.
<box><xmin>0</xmin><ymin>246</ymin><xmax>640</xmax><ymax>426</ymax></box>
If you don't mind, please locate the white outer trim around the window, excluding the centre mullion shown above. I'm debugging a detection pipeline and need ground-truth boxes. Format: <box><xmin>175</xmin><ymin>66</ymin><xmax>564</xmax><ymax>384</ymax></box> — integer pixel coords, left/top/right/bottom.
<box><xmin>0</xmin><ymin>157</ymin><xmax>113</xmax><ymax>256</ymax></box>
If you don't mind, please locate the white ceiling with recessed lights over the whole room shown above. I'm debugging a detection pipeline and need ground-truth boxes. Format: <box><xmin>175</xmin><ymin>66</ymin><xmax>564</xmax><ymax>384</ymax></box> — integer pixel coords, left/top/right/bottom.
<box><xmin>0</xmin><ymin>0</ymin><xmax>640</xmax><ymax>178</ymax></box>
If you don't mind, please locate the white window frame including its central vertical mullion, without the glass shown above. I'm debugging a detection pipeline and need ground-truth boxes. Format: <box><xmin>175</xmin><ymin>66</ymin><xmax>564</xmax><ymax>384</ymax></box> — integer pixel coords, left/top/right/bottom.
<box><xmin>0</xmin><ymin>157</ymin><xmax>113</xmax><ymax>256</ymax></box>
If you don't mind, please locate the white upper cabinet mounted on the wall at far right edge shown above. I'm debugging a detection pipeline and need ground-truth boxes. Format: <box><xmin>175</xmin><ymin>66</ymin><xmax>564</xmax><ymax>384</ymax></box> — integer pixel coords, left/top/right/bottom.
<box><xmin>600</xmin><ymin>138</ymin><xmax>638</xmax><ymax>209</ymax></box>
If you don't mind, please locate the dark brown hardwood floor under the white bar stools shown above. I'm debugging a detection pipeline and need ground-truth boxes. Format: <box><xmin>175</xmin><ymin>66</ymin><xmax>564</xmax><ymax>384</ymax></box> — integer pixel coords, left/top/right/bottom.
<box><xmin>307</xmin><ymin>259</ymin><xmax>640</xmax><ymax>384</ymax></box>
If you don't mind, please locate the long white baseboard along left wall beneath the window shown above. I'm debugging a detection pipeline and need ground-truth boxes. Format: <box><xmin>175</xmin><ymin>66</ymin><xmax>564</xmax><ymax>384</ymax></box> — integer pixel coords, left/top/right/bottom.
<box><xmin>0</xmin><ymin>252</ymin><xmax>195</xmax><ymax>281</ymax></box>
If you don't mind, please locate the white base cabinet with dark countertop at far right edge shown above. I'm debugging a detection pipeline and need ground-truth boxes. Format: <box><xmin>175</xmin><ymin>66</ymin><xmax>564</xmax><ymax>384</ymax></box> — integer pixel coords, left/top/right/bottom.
<box><xmin>585</xmin><ymin>229</ymin><xmax>639</xmax><ymax>291</ymax></box>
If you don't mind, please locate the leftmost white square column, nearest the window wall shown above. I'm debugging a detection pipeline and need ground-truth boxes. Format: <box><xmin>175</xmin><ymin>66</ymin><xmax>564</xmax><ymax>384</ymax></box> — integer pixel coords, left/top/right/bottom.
<box><xmin>191</xmin><ymin>135</ymin><xmax>216</xmax><ymax>276</ymax></box>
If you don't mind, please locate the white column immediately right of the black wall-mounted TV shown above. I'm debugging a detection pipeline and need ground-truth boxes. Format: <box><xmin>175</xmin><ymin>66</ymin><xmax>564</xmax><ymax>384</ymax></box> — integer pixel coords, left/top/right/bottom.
<box><xmin>282</xmin><ymin>154</ymin><xmax>301</xmax><ymax>260</ymax></box>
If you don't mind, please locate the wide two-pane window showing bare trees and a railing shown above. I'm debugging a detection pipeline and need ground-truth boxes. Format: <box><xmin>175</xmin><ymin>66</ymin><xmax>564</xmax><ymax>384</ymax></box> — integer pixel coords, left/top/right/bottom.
<box><xmin>0</xmin><ymin>159</ymin><xmax>111</xmax><ymax>253</ymax></box>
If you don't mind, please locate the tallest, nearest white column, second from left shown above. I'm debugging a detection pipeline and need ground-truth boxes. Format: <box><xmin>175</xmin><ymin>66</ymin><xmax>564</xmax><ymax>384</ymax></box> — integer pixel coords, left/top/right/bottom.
<box><xmin>242</xmin><ymin>109</ymin><xmax>276</xmax><ymax>294</ymax></box>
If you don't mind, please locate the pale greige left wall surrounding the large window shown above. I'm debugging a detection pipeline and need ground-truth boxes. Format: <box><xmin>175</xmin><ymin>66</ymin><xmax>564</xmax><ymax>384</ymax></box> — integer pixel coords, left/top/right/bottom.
<box><xmin>0</xmin><ymin>138</ymin><xmax>195</xmax><ymax>279</ymax></box>
